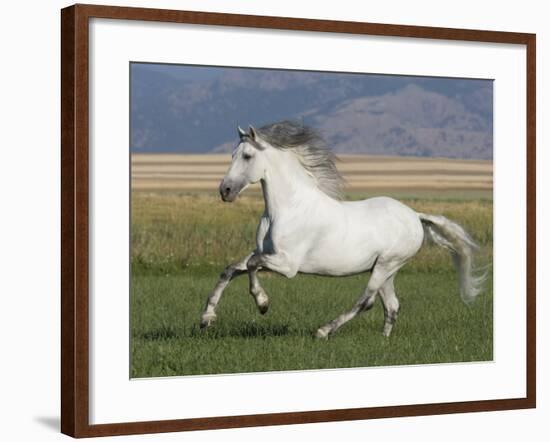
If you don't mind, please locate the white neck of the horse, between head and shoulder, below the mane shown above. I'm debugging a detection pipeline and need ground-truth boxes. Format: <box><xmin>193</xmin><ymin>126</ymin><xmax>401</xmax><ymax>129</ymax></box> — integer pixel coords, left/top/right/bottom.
<box><xmin>262</xmin><ymin>155</ymin><xmax>329</xmax><ymax>221</ymax></box>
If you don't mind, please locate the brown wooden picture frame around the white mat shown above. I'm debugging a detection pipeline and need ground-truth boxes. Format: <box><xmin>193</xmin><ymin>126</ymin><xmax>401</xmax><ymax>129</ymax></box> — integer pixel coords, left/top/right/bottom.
<box><xmin>61</xmin><ymin>5</ymin><xmax>536</xmax><ymax>437</ymax></box>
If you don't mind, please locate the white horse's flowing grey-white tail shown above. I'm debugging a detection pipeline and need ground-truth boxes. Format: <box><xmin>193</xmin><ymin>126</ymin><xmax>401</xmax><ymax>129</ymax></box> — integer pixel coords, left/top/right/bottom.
<box><xmin>418</xmin><ymin>213</ymin><xmax>486</xmax><ymax>304</ymax></box>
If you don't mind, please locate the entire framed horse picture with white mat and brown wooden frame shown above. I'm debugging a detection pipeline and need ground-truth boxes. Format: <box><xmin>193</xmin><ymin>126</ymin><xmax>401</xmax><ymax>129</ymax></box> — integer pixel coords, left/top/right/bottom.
<box><xmin>61</xmin><ymin>5</ymin><xmax>536</xmax><ymax>437</ymax></box>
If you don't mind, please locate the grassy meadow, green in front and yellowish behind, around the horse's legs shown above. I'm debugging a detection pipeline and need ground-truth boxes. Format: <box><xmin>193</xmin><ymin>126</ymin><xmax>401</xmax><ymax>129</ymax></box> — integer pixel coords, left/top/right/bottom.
<box><xmin>131</xmin><ymin>193</ymin><xmax>493</xmax><ymax>377</ymax></box>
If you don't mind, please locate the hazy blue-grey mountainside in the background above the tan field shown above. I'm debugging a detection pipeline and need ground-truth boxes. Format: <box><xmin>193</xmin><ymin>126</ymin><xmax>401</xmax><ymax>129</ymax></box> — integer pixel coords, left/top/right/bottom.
<box><xmin>131</xmin><ymin>64</ymin><xmax>493</xmax><ymax>159</ymax></box>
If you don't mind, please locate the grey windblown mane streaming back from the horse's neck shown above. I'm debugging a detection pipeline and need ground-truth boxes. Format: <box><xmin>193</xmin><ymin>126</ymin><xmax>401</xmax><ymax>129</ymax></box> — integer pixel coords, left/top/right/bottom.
<box><xmin>257</xmin><ymin>120</ymin><xmax>345</xmax><ymax>200</ymax></box>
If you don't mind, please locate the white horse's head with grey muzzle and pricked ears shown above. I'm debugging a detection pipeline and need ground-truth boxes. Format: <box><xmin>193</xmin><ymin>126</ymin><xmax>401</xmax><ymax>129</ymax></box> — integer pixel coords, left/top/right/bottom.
<box><xmin>220</xmin><ymin>126</ymin><xmax>267</xmax><ymax>202</ymax></box>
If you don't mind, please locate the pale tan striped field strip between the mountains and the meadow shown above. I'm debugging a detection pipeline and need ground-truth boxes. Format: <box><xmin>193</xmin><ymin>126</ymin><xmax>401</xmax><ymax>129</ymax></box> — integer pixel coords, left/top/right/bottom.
<box><xmin>132</xmin><ymin>154</ymin><xmax>493</xmax><ymax>190</ymax></box>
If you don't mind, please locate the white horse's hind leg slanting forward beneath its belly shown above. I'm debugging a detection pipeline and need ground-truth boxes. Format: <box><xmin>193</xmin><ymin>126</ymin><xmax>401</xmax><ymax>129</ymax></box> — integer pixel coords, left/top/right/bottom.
<box><xmin>315</xmin><ymin>263</ymin><xmax>400</xmax><ymax>338</ymax></box>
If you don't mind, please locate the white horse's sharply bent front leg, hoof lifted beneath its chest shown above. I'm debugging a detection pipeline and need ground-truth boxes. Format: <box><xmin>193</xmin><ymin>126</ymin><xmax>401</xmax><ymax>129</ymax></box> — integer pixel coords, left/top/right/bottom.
<box><xmin>246</xmin><ymin>253</ymin><xmax>297</xmax><ymax>315</ymax></box>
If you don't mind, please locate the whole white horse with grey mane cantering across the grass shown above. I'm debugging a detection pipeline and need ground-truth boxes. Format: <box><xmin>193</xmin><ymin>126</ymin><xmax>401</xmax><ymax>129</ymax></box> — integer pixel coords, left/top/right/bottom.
<box><xmin>201</xmin><ymin>121</ymin><xmax>483</xmax><ymax>338</ymax></box>
